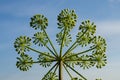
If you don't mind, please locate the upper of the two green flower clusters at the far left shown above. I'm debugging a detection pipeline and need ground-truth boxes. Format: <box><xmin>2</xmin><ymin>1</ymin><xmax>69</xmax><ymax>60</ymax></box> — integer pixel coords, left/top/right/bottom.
<box><xmin>14</xmin><ymin>36</ymin><xmax>31</xmax><ymax>55</ymax></box>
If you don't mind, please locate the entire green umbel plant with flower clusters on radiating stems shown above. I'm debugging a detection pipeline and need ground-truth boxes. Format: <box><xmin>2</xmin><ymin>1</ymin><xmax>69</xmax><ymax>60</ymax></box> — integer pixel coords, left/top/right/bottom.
<box><xmin>14</xmin><ymin>9</ymin><xmax>107</xmax><ymax>80</ymax></box>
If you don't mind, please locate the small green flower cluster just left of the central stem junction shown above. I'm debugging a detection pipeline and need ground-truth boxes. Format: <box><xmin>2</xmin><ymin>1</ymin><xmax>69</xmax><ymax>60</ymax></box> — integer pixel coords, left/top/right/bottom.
<box><xmin>38</xmin><ymin>52</ymin><xmax>53</xmax><ymax>67</ymax></box>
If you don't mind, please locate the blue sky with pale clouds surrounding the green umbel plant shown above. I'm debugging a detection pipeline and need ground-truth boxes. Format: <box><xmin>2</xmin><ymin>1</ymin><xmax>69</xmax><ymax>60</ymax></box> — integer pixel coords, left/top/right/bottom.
<box><xmin>0</xmin><ymin>0</ymin><xmax>120</xmax><ymax>80</ymax></box>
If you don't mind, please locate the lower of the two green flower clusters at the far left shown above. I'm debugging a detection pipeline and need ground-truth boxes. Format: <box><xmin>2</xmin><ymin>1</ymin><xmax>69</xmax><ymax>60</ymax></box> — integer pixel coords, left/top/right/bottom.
<box><xmin>16</xmin><ymin>54</ymin><xmax>33</xmax><ymax>71</ymax></box>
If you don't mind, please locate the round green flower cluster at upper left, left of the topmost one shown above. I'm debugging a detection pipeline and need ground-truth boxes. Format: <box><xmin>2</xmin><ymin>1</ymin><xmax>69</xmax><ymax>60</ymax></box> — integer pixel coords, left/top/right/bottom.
<box><xmin>30</xmin><ymin>14</ymin><xmax>48</xmax><ymax>30</ymax></box>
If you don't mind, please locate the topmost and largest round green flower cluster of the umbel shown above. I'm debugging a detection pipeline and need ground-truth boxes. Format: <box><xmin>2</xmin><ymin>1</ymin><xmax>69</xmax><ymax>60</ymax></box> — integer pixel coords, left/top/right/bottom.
<box><xmin>58</xmin><ymin>9</ymin><xmax>77</xmax><ymax>30</ymax></box>
